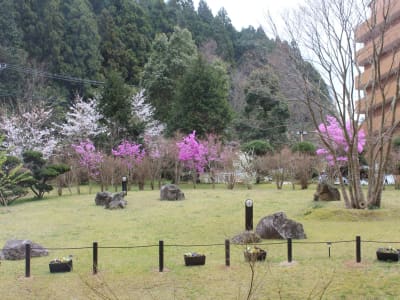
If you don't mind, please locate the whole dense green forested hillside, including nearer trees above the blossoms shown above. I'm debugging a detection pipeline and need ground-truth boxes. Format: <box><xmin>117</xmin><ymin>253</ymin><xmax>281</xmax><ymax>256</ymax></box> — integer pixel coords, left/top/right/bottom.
<box><xmin>0</xmin><ymin>0</ymin><xmax>329</xmax><ymax>144</ymax></box>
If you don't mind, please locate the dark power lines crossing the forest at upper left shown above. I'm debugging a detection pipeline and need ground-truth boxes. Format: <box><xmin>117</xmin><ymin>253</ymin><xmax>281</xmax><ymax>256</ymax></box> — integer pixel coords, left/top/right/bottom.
<box><xmin>0</xmin><ymin>63</ymin><xmax>104</xmax><ymax>85</ymax></box>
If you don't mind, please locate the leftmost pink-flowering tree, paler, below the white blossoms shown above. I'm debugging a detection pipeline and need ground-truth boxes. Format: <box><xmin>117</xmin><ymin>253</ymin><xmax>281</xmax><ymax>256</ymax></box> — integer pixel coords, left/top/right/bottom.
<box><xmin>72</xmin><ymin>139</ymin><xmax>104</xmax><ymax>193</ymax></box>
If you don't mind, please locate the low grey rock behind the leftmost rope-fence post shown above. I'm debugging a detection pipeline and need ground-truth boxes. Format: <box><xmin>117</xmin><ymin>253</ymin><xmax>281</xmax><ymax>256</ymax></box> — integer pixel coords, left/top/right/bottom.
<box><xmin>0</xmin><ymin>240</ymin><xmax>49</xmax><ymax>260</ymax></box>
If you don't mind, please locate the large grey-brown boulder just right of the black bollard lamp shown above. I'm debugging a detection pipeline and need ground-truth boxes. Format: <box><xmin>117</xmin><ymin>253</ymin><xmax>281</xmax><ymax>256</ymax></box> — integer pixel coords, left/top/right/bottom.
<box><xmin>256</xmin><ymin>212</ymin><xmax>307</xmax><ymax>239</ymax></box>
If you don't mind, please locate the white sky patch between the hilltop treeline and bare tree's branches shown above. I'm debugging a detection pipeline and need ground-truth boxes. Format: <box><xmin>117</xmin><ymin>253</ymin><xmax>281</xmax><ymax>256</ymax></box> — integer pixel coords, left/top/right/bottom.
<box><xmin>193</xmin><ymin>0</ymin><xmax>301</xmax><ymax>31</ymax></box>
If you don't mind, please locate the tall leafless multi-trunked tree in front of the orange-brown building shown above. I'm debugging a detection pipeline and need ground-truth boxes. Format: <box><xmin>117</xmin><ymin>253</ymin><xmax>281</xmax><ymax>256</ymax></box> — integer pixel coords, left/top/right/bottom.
<box><xmin>276</xmin><ymin>0</ymin><xmax>399</xmax><ymax>209</ymax></box>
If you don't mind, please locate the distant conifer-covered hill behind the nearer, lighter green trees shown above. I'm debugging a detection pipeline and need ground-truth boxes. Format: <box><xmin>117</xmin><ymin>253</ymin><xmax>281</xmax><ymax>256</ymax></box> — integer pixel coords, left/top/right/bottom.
<box><xmin>0</xmin><ymin>0</ymin><xmax>329</xmax><ymax>140</ymax></box>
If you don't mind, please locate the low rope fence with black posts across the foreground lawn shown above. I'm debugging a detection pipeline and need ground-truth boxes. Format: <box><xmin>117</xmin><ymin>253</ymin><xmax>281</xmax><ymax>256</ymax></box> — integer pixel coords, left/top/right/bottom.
<box><xmin>3</xmin><ymin>236</ymin><xmax>400</xmax><ymax>277</ymax></box>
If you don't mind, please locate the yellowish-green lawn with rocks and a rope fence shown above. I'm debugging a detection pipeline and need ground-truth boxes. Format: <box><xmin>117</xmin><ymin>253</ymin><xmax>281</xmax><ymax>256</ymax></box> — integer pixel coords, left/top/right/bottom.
<box><xmin>0</xmin><ymin>185</ymin><xmax>400</xmax><ymax>299</ymax></box>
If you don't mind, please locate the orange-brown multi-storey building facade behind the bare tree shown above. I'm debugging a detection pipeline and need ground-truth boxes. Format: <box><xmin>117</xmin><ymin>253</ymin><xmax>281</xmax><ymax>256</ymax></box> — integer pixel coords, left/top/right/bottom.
<box><xmin>355</xmin><ymin>0</ymin><xmax>400</xmax><ymax>135</ymax></box>
